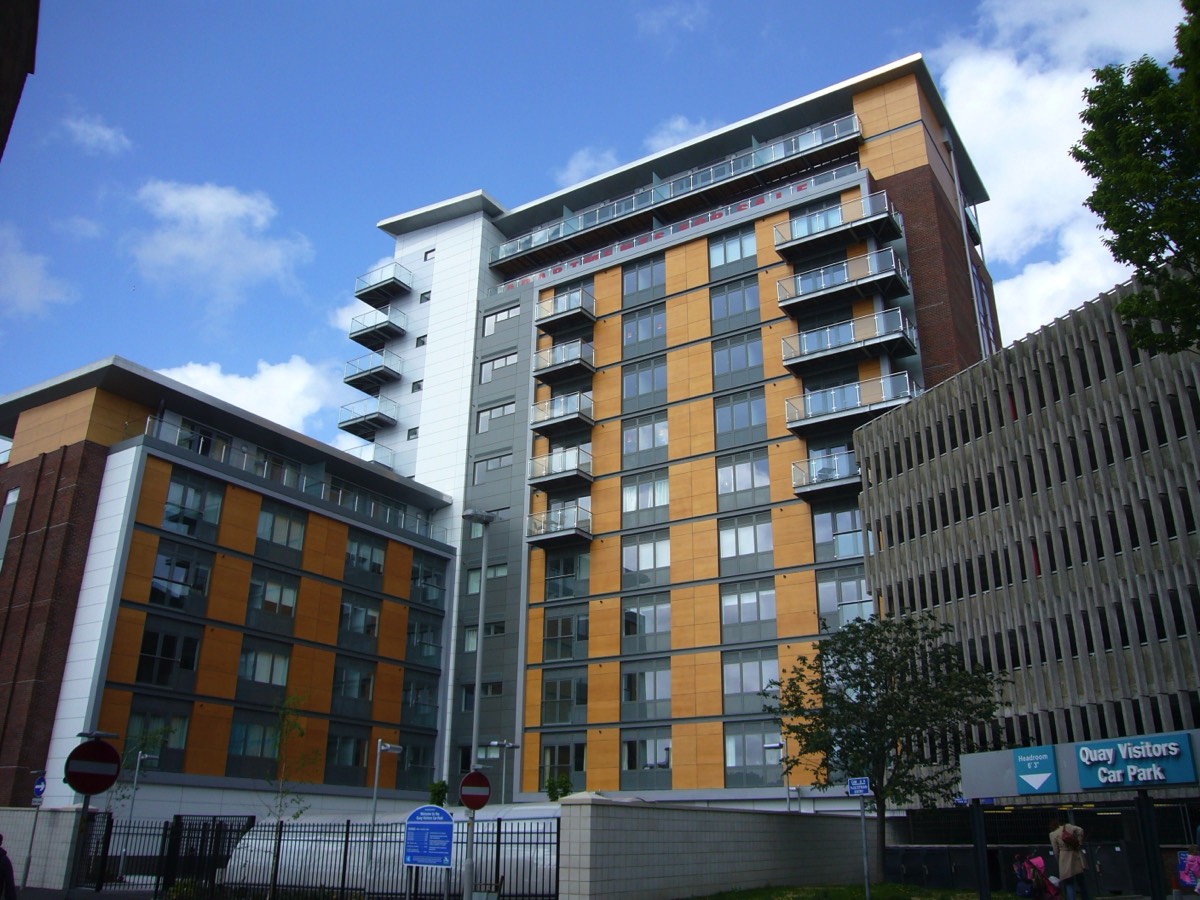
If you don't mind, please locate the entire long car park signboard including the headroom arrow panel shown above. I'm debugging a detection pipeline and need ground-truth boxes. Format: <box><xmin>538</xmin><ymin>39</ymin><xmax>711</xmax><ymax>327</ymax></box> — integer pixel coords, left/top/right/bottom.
<box><xmin>961</xmin><ymin>731</ymin><xmax>1200</xmax><ymax>799</ymax></box>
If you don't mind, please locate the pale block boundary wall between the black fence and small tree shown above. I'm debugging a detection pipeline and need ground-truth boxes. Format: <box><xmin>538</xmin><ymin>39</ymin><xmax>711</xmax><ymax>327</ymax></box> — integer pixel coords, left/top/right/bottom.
<box><xmin>559</xmin><ymin>794</ymin><xmax>874</xmax><ymax>900</ymax></box>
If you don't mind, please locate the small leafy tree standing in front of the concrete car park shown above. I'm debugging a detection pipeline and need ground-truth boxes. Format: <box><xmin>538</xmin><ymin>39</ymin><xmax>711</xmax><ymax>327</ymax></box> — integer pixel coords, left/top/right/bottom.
<box><xmin>764</xmin><ymin>616</ymin><xmax>1003</xmax><ymax>875</ymax></box>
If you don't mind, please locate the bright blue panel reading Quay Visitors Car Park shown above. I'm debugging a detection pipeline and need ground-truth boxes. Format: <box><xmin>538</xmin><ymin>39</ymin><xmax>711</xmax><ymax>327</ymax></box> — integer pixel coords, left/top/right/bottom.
<box><xmin>1075</xmin><ymin>732</ymin><xmax>1196</xmax><ymax>791</ymax></box>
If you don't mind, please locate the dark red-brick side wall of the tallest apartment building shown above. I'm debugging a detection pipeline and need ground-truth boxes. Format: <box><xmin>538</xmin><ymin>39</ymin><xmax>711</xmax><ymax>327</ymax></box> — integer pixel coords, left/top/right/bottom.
<box><xmin>878</xmin><ymin>167</ymin><xmax>998</xmax><ymax>388</ymax></box>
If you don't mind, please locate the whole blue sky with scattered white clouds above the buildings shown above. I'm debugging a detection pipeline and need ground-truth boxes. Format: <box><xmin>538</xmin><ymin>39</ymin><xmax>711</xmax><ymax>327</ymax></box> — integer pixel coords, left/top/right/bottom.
<box><xmin>0</xmin><ymin>0</ymin><xmax>1183</xmax><ymax>446</ymax></box>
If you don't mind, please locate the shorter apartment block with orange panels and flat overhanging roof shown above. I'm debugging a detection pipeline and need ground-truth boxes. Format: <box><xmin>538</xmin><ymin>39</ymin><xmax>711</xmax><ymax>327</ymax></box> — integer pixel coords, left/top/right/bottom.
<box><xmin>0</xmin><ymin>358</ymin><xmax>452</xmax><ymax>816</ymax></box>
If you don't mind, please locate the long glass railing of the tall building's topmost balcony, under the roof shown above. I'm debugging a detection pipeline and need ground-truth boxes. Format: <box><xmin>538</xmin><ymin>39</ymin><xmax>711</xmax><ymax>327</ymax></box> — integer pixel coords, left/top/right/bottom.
<box><xmin>490</xmin><ymin>115</ymin><xmax>859</xmax><ymax>263</ymax></box>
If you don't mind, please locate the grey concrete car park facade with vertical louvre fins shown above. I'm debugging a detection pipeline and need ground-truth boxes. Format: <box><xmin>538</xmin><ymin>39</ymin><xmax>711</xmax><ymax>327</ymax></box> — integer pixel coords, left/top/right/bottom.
<box><xmin>854</xmin><ymin>284</ymin><xmax>1200</xmax><ymax>800</ymax></box>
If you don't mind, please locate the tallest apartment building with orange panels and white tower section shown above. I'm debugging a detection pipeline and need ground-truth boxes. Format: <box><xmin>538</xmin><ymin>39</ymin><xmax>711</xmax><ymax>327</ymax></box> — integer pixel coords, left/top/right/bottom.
<box><xmin>342</xmin><ymin>56</ymin><xmax>998</xmax><ymax>802</ymax></box>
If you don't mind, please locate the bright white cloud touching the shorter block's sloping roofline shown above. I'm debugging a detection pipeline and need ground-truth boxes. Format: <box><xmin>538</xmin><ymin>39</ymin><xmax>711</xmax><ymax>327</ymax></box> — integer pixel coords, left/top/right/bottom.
<box><xmin>158</xmin><ymin>355</ymin><xmax>343</xmax><ymax>434</ymax></box>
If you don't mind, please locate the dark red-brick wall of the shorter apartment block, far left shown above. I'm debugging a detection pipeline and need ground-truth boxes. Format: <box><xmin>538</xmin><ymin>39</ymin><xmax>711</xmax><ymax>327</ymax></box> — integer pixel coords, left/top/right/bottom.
<box><xmin>0</xmin><ymin>442</ymin><xmax>108</xmax><ymax>806</ymax></box>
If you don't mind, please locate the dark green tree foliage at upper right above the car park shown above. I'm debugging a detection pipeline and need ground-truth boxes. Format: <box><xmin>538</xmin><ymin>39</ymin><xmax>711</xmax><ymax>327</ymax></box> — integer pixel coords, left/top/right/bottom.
<box><xmin>1070</xmin><ymin>0</ymin><xmax>1200</xmax><ymax>353</ymax></box>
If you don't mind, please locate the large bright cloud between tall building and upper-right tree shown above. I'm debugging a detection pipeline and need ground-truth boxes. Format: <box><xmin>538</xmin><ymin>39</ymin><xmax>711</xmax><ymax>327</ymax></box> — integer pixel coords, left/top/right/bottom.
<box><xmin>930</xmin><ymin>0</ymin><xmax>1183</xmax><ymax>342</ymax></box>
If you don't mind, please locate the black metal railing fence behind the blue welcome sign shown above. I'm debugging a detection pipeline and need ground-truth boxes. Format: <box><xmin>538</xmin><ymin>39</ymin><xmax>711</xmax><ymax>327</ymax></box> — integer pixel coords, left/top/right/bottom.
<box><xmin>74</xmin><ymin>814</ymin><xmax>559</xmax><ymax>900</ymax></box>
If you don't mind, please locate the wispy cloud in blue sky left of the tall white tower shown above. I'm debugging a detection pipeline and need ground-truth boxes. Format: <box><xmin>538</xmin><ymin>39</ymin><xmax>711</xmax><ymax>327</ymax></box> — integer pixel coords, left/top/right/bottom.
<box><xmin>132</xmin><ymin>181</ymin><xmax>312</xmax><ymax>313</ymax></box>
